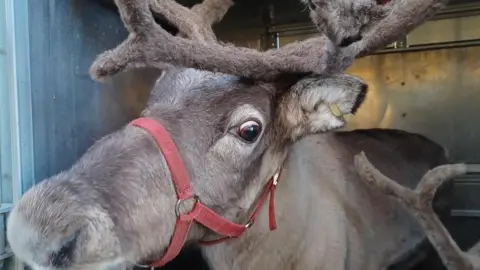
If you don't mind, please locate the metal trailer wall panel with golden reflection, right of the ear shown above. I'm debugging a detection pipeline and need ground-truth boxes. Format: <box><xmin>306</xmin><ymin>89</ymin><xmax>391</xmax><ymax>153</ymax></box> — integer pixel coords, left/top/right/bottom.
<box><xmin>346</xmin><ymin>46</ymin><xmax>480</xmax><ymax>216</ymax></box>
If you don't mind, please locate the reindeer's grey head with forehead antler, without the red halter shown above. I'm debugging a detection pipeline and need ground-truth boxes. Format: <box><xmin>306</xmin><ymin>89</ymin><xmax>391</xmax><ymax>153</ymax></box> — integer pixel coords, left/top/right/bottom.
<box><xmin>7</xmin><ymin>0</ymin><xmax>448</xmax><ymax>270</ymax></box>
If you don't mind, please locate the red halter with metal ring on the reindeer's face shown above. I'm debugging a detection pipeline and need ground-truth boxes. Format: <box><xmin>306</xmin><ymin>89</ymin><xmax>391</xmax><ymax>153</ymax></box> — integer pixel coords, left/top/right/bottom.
<box><xmin>130</xmin><ymin>118</ymin><xmax>279</xmax><ymax>269</ymax></box>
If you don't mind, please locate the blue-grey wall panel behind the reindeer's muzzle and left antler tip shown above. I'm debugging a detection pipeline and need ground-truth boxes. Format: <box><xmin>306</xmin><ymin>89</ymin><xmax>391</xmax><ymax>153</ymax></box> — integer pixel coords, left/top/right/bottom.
<box><xmin>29</xmin><ymin>0</ymin><xmax>158</xmax><ymax>181</ymax></box>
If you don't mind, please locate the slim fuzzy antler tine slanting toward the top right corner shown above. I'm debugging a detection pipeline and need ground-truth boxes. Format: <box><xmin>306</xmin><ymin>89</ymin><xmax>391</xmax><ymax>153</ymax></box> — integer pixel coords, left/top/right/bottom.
<box><xmin>353</xmin><ymin>0</ymin><xmax>448</xmax><ymax>56</ymax></box>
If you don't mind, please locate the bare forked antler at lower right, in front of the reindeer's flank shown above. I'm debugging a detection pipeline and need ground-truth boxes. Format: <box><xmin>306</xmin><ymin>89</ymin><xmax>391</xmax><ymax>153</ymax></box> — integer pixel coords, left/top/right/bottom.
<box><xmin>355</xmin><ymin>152</ymin><xmax>480</xmax><ymax>270</ymax></box>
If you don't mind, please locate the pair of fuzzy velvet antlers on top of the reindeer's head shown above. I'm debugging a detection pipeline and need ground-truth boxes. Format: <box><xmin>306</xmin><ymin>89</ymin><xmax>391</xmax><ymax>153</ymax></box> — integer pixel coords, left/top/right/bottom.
<box><xmin>90</xmin><ymin>0</ymin><xmax>447</xmax><ymax>81</ymax></box>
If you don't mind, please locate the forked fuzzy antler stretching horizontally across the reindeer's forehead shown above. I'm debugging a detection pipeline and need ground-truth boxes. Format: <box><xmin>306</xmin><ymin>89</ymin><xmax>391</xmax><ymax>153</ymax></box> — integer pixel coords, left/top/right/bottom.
<box><xmin>90</xmin><ymin>0</ymin><xmax>333</xmax><ymax>80</ymax></box>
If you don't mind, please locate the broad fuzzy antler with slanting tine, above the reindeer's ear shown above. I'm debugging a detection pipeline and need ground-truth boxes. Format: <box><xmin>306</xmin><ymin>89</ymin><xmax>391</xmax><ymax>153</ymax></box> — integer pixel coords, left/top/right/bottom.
<box><xmin>301</xmin><ymin>0</ymin><xmax>448</xmax><ymax>72</ymax></box>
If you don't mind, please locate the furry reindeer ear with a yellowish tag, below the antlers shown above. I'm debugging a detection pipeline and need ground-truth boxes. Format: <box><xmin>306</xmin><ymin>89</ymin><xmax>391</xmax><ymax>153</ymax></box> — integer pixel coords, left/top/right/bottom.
<box><xmin>278</xmin><ymin>74</ymin><xmax>367</xmax><ymax>140</ymax></box>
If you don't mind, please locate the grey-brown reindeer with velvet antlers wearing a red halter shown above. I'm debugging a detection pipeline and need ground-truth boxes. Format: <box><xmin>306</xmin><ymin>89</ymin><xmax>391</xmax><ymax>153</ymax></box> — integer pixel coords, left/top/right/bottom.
<box><xmin>3</xmin><ymin>0</ymin><xmax>451</xmax><ymax>270</ymax></box>
